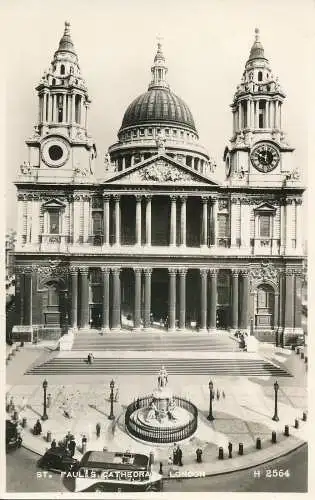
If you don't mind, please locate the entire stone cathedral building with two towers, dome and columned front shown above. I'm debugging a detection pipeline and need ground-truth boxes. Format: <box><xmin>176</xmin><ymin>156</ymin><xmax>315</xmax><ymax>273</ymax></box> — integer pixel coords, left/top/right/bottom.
<box><xmin>13</xmin><ymin>22</ymin><xmax>304</xmax><ymax>349</ymax></box>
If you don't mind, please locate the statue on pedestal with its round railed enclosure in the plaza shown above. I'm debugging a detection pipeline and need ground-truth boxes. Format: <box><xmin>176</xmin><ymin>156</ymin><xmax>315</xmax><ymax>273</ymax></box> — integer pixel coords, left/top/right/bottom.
<box><xmin>125</xmin><ymin>366</ymin><xmax>198</xmax><ymax>443</ymax></box>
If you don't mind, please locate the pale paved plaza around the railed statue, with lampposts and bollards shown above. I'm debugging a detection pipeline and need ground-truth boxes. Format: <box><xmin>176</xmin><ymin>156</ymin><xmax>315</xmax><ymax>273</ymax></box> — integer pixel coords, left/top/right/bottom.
<box><xmin>7</xmin><ymin>344</ymin><xmax>308</xmax><ymax>475</ymax></box>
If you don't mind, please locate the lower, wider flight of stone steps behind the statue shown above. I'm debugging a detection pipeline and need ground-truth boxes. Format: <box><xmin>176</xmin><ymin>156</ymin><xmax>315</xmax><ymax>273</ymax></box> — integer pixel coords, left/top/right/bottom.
<box><xmin>26</xmin><ymin>356</ymin><xmax>292</xmax><ymax>377</ymax></box>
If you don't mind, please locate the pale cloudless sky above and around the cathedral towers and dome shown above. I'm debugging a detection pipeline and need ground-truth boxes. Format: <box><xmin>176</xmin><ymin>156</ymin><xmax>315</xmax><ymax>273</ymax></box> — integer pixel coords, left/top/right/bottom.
<box><xmin>0</xmin><ymin>0</ymin><xmax>314</xmax><ymax>228</ymax></box>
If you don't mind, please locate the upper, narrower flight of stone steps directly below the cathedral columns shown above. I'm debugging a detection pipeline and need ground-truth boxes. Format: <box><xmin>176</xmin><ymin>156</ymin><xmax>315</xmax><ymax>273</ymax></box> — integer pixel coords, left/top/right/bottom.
<box><xmin>72</xmin><ymin>331</ymin><xmax>239</xmax><ymax>352</ymax></box>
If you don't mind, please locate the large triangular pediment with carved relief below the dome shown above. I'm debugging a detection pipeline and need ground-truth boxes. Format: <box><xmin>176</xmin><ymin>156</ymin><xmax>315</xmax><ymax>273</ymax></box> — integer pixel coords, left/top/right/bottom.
<box><xmin>105</xmin><ymin>154</ymin><xmax>217</xmax><ymax>186</ymax></box>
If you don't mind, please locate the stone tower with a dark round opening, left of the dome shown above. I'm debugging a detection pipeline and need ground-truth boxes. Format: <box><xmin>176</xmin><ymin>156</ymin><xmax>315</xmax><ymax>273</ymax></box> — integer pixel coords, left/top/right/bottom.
<box><xmin>26</xmin><ymin>22</ymin><xmax>96</xmax><ymax>182</ymax></box>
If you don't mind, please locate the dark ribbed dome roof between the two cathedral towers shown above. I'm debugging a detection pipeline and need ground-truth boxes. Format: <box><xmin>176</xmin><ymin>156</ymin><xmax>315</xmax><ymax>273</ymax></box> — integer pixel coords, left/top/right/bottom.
<box><xmin>120</xmin><ymin>86</ymin><xmax>196</xmax><ymax>132</ymax></box>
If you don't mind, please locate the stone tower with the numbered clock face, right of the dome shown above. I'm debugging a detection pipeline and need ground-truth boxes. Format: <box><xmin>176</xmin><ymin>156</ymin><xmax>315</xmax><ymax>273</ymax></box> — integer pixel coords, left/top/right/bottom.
<box><xmin>223</xmin><ymin>28</ymin><xmax>294</xmax><ymax>187</ymax></box>
